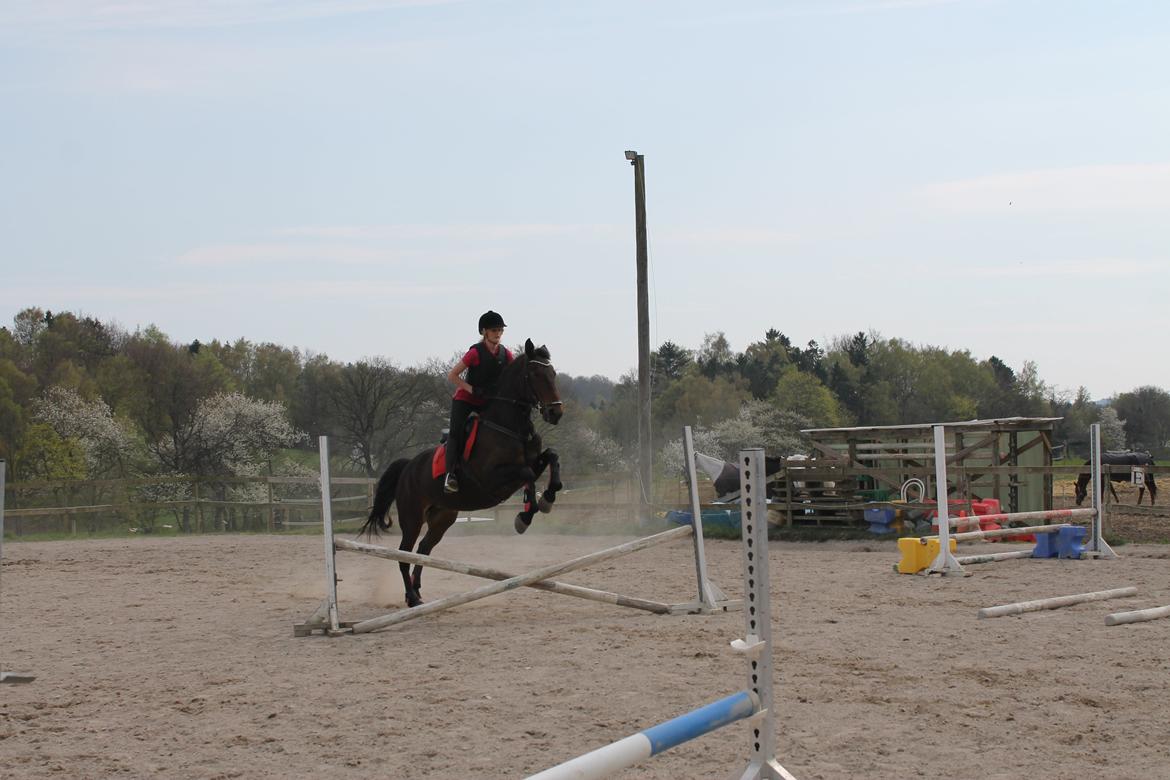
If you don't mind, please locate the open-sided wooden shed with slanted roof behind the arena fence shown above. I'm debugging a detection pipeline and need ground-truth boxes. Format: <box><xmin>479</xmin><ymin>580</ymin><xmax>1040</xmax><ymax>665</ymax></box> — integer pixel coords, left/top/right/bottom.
<box><xmin>800</xmin><ymin>417</ymin><xmax>1060</xmax><ymax>512</ymax></box>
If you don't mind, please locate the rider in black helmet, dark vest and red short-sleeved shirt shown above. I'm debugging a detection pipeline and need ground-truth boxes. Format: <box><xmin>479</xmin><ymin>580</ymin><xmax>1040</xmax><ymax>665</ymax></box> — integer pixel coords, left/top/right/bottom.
<box><xmin>442</xmin><ymin>311</ymin><xmax>512</xmax><ymax>493</ymax></box>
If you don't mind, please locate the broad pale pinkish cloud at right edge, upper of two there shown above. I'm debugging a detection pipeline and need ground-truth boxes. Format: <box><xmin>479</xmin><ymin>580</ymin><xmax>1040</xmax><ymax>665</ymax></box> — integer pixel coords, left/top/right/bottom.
<box><xmin>920</xmin><ymin>164</ymin><xmax>1170</xmax><ymax>214</ymax></box>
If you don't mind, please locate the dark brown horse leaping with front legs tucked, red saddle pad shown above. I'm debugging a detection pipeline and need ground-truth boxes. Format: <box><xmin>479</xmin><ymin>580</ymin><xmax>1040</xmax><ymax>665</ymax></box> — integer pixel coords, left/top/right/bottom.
<box><xmin>359</xmin><ymin>339</ymin><xmax>563</xmax><ymax>607</ymax></box>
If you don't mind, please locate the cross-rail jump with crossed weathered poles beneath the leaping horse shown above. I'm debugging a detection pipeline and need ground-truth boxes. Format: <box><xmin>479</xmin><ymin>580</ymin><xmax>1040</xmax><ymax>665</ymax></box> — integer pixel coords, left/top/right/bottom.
<box><xmin>293</xmin><ymin>430</ymin><xmax>742</xmax><ymax>636</ymax></box>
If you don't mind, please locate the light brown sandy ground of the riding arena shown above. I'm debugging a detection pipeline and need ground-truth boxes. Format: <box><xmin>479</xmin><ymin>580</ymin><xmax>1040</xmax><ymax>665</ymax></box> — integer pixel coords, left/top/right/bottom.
<box><xmin>0</xmin><ymin>523</ymin><xmax>1170</xmax><ymax>780</ymax></box>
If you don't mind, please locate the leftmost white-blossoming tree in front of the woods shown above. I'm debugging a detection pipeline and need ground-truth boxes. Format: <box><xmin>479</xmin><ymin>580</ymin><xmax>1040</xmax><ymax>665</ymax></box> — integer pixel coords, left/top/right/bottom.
<box><xmin>34</xmin><ymin>386</ymin><xmax>143</xmax><ymax>478</ymax></box>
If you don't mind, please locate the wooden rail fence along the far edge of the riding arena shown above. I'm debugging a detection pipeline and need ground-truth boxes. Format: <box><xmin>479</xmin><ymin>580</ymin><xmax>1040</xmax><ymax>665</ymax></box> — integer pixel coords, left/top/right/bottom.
<box><xmin>5</xmin><ymin>458</ymin><xmax>1170</xmax><ymax>537</ymax></box>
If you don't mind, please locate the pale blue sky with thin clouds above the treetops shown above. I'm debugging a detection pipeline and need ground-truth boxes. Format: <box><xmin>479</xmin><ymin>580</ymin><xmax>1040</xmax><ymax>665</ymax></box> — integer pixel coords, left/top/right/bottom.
<box><xmin>0</xmin><ymin>0</ymin><xmax>1170</xmax><ymax>399</ymax></box>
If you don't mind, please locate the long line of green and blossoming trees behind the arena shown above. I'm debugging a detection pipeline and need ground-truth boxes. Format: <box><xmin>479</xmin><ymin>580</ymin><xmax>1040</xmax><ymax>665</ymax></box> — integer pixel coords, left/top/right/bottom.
<box><xmin>0</xmin><ymin>308</ymin><xmax>1170</xmax><ymax>481</ymax></box>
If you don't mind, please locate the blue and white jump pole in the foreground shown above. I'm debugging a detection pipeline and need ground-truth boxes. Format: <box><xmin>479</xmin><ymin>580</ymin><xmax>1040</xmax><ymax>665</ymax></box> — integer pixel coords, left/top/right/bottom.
<box><xmin>528</xmin><ymin>691</ymin><xmax>759</xmax><ymax>780</ymax></box>
